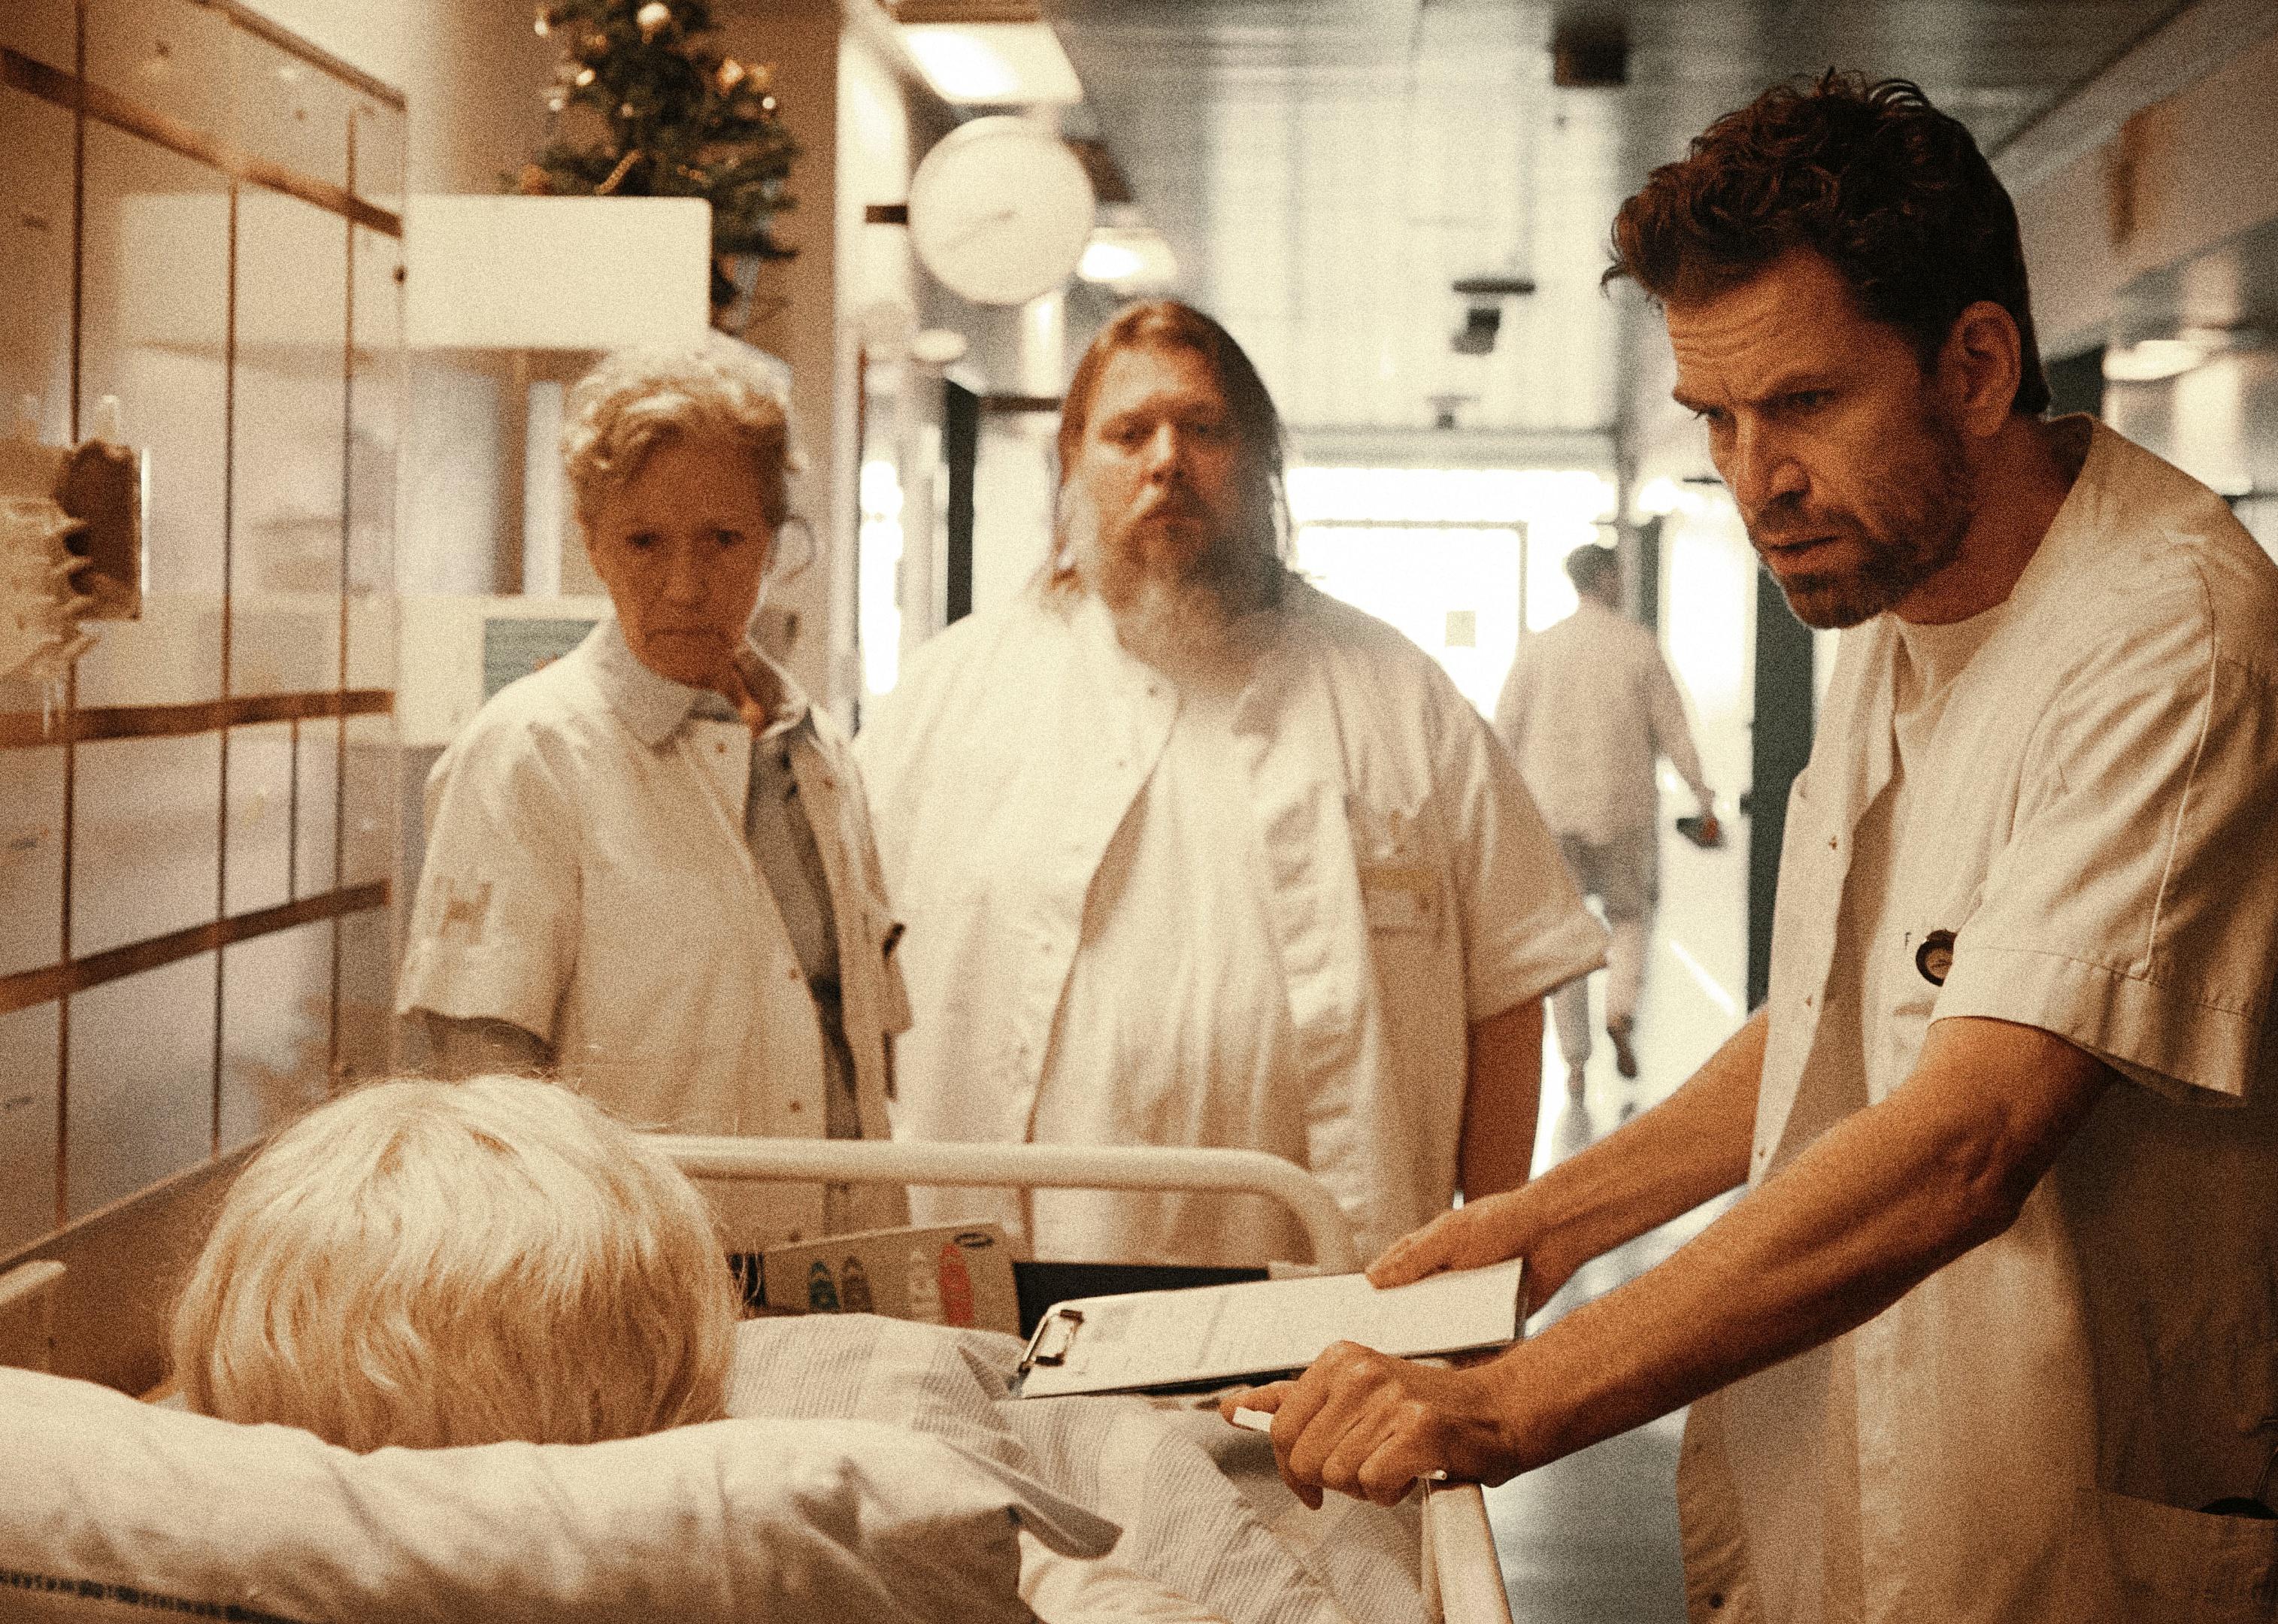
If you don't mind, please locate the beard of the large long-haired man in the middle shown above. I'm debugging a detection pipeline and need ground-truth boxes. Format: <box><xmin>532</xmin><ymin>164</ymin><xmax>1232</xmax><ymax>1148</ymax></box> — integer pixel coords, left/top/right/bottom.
<box><xmin>1059</xmin><ymin>480</ymin><xmax>1287</xmax><ymax>672</ymax></box>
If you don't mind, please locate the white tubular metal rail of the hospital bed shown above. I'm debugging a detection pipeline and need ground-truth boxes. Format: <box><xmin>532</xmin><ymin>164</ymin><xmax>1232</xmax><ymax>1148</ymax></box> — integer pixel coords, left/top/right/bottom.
<box><xmin>654</xmin><ymin>1135</ymin><xmax>1513</xmax><ymax>1624</ymax></box>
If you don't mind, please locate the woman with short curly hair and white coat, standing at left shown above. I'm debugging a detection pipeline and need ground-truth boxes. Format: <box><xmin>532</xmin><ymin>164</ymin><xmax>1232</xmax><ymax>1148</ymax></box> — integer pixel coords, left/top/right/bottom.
<box><xmin>396</xmin><ymin>337</ymin><xmax>909</xmax><ymax>1250</ymax></box>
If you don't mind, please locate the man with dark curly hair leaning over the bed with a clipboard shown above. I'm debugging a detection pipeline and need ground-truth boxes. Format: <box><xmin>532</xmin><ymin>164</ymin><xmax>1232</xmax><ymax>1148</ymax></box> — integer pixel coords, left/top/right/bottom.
<box><xmin>1244</xmin><ymin>75</ymin><xmax>2278</xmax><ymax>1624</ymax></box>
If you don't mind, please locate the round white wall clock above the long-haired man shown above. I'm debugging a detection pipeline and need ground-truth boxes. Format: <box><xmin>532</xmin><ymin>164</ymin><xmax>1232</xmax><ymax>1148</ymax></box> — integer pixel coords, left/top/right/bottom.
<box><xmin>909</xmin><ymin>117</ymin><xmax>1093</xmax><ymax>305</ymax></box>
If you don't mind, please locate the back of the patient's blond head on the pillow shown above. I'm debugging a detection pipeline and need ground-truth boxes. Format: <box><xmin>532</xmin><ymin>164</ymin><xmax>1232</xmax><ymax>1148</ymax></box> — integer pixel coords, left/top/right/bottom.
<box><xmin>173</xmin><ymin>1077</ymin><xmax>736</xmax><ymax>1449</ymax></box>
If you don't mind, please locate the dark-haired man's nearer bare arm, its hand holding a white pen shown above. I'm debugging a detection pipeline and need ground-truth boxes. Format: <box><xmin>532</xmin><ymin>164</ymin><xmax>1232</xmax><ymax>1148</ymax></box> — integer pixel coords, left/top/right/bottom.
<box><xmin>1241</xmin><ymin>1018</ymin><xmax>2112</xmax><ymax>1503</ymax></box>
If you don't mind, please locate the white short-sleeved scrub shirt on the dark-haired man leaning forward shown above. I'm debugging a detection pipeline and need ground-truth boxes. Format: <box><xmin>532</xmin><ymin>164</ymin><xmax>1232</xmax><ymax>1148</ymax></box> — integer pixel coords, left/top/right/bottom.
<box><xmin>1679</xmin><ymin>419</ymin><xmax>2278</xmax><ymax>1624</ymax></box>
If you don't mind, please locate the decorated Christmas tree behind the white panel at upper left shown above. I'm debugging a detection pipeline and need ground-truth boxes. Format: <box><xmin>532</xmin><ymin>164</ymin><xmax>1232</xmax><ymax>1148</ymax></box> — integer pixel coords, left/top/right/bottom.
<box><xmin>510</xmin><ymin>0</ymin><xmax>800</xmax><ymax>308</ymax></box>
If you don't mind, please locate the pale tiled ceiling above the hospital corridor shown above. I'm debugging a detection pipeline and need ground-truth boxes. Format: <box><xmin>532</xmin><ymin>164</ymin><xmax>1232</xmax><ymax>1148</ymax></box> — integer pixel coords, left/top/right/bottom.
<box><xmin>1048</xmin><ymin>0</ymin><xmax>2183</xmax><ymax>435</ymax></box>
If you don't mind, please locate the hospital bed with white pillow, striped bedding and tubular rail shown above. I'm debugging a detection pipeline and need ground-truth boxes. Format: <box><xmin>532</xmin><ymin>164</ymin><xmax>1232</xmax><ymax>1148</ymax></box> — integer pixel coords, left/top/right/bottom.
<box><xmin>0</xmin><ymin>1139</ymin><xmax>1510</xmax><ymax>1624</ymax></box>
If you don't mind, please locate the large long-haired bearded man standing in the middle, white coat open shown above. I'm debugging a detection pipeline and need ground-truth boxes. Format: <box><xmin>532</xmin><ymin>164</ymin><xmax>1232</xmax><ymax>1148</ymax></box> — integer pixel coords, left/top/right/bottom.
<box><xmin>856</xmin><ymin>301</ymin><xmax>1604</xmax><ymax>1264</ymax></box>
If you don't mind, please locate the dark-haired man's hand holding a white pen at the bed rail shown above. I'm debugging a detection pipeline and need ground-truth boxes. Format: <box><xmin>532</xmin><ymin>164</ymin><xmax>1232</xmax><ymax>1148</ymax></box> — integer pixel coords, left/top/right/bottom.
<box><xmin>1219</xmin><ymin>1341</ymin><xmax>1519</xmax><ymax>1510</ymax></box>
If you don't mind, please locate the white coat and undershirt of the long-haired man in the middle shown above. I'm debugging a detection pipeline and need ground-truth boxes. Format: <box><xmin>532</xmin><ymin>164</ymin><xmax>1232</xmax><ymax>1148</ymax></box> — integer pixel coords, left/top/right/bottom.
<box><xmin>856</xmin><ymin>581</ymin><xmax>1604</xmax><ymax>1262</ymax></box>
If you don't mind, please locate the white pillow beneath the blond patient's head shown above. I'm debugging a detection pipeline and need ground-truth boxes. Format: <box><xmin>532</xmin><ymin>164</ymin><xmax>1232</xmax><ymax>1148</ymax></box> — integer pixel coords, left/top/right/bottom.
<box><xmin>0</xmin><ymin>1369</ymin><xmax>1116</xmax><ymax>1624</ymax></box>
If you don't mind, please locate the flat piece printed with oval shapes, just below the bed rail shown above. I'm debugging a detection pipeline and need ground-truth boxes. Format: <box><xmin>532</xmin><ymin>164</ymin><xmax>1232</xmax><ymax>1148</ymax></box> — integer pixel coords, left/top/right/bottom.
<box><xmin>761</xmin><ymin>1223</ymin><xmax>1020</xmax><ymax>1337</ymax></box>
